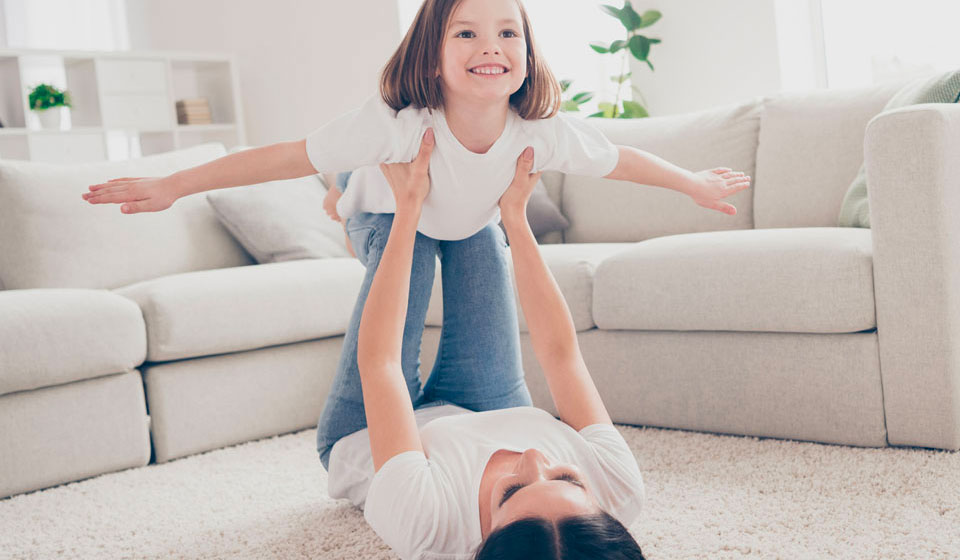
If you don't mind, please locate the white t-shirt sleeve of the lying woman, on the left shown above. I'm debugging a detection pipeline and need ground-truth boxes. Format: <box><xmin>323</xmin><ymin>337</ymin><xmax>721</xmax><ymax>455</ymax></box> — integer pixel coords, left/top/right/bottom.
<box><xmin>363</xmin><ymin>451</ymin><xmax>451</xmax><ymax>560</ymax></box>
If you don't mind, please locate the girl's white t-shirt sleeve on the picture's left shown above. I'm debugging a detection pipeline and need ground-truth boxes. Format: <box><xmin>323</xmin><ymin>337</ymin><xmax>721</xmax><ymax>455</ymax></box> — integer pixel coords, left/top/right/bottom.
<box><xmin>306</xmin><ymin>95</ymin><xmax>422</xmax><ymax>173</ymax></box>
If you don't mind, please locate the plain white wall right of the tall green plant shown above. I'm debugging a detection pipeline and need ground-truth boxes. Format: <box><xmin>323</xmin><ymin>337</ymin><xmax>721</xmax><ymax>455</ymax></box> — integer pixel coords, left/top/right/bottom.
<box><xmin>631</xmin><ymin>0</ymin><xmax>784</xmax><ymax>116</ymax></box>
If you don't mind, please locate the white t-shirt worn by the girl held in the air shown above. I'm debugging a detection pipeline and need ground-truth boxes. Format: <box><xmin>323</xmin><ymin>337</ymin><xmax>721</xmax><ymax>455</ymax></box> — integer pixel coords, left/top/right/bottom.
<box><xmin>306</xmin><ymin>95</ymin><xmax>620</xmax><ymax>241</ymax></box>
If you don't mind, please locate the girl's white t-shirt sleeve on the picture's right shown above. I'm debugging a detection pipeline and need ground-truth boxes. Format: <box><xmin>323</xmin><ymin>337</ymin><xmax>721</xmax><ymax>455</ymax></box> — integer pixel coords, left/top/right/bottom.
<box><xmin>533</xmin><ymin>113</ymin><xmax>620</xmax><ymax>177</ymax></box>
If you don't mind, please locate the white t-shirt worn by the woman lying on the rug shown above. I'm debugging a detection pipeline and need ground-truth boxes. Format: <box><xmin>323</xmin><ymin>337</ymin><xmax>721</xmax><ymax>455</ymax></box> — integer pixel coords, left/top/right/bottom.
<box><xmin>328</xmin><ymin>404</ymin><xmax>644</xmax><ymax>560</ymax></box>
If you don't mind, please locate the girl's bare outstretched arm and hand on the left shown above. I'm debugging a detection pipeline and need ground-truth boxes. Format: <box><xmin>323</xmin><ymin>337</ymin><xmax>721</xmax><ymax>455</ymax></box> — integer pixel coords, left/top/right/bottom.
<box><xmin>83</xmin><ymin>140</ymin><xmax>317</xmax><ymax>214</ymax></box>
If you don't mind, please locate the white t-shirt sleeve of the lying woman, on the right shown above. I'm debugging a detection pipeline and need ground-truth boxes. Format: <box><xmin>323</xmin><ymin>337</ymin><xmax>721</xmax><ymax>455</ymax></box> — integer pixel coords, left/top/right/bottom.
<box><xmin>580</xmin><ymin>424</ymin><xmax>645</xmax><ymax>527</ymax></box>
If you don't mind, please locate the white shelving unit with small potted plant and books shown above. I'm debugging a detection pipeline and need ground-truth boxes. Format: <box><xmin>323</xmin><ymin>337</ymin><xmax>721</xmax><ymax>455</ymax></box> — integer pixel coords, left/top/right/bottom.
<box><xmin>0</xmin><ymin>49</ymin><xmax>246</xmax><ymax>163</ymax></box>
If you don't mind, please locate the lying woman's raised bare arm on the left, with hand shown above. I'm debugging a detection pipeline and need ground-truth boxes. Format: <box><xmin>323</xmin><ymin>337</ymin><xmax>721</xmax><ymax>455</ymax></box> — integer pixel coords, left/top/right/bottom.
<box><xmin>357</xmin><ymin>129</ymin><xmax>434</xmax><ymax>471</ymax></box>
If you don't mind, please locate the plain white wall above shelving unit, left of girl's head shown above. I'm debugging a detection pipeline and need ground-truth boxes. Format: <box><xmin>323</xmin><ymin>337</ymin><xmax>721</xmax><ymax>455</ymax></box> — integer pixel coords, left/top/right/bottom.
<box><xmin>127</xmin><ymin>0</ymin><xmax>400</xmax><ymax>146</ymax></box>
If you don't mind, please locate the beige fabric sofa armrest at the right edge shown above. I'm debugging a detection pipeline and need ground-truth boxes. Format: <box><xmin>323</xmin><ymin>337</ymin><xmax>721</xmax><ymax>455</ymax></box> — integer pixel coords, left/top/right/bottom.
<box><xmin>864</xmin><ymin>103</ymin><xmax>960</xmax><ymax>449</ymax></box>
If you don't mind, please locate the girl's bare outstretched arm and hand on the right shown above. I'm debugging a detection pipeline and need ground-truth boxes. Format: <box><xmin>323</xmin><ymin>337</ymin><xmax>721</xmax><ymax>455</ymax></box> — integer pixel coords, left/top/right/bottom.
<box><xmin>604</xmin><ymin>146</ymin><xmax>750</xmax><ymax>216</ymax></box>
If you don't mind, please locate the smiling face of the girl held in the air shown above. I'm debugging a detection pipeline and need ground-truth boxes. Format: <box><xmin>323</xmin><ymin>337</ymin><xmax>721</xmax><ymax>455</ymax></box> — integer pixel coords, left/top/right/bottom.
<box><xmin>440</xmin><ymin>0</ymin><xmax>527</xmax><ymax>103</ymax></box>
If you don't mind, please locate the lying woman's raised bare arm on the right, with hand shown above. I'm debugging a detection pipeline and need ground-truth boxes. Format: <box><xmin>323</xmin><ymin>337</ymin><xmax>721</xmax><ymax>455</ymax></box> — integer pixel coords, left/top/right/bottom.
<box><xmin>500</xmin><ymin>148</ymin><xmax>612</xmax><ymax>431</ymax></box>
